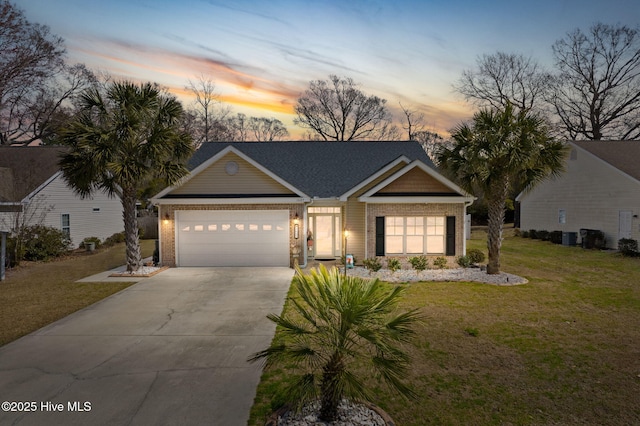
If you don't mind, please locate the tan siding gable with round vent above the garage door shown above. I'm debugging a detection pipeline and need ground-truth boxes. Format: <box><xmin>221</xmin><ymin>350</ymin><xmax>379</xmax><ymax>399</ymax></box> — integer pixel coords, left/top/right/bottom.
<box><xmin>167</xmin><ymin>152</ymin><xmax>296</xmax><ymax>198</ymax></box>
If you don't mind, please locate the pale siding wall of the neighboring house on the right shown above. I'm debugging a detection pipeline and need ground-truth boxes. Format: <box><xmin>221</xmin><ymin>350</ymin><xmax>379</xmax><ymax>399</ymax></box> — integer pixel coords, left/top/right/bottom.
<box><xmin>520</xmin><ymin>148</ymin><xmax>640</xmax><ymax>248</ymax></box>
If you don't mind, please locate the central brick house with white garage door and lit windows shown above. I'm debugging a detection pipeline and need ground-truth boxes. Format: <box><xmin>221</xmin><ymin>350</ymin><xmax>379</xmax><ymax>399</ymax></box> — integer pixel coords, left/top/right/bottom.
<box><xmin>152</xmin><ymin>141</ymin><xmax>474</xmax><ymax>266</ymax></box>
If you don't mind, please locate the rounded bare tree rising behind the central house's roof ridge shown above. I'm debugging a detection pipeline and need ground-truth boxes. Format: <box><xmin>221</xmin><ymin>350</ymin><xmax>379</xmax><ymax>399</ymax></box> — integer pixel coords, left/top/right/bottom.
<box><xmin>294</xmin><ymin>75</ymin><xmax>390</xmax><ymax>141</ymax></box>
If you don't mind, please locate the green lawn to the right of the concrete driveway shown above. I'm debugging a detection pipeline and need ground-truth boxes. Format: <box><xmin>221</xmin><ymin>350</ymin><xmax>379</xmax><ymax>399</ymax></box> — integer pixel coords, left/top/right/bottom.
<box><xmin>249</xmin><ymin>230</ymin><xmax>640</xmax><ymax>426</ymax></box>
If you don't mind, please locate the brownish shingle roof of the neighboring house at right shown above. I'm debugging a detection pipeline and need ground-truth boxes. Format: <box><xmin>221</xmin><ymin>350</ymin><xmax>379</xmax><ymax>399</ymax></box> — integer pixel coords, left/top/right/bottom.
<box><xmin>573</xmin><ymin>141</ymin><xmax>640</xmax><ymax>180</ymax></box>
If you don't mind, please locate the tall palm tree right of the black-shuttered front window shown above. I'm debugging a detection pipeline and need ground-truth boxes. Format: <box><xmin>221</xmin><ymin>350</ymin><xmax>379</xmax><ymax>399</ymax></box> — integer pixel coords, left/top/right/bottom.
<box><xmin>436</xmin><ymin>104</ymin><xmax>566</xmax><ymax>274</ymax></box>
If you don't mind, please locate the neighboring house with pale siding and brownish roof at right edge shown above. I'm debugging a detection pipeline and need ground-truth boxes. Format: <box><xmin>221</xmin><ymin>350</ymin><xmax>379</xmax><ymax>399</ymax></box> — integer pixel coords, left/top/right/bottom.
<box><xmin>516</xmin><ymin>141</ymin><xmax>640</xmax><ymax>248</ymax></box>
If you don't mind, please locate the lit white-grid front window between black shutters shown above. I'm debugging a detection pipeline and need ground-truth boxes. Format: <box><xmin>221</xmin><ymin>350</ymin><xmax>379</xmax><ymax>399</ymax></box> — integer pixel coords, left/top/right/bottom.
<box><xmin>385</xmin><ymin>216</ymin><xmax>445</xmax><ymax>255</ymax></box>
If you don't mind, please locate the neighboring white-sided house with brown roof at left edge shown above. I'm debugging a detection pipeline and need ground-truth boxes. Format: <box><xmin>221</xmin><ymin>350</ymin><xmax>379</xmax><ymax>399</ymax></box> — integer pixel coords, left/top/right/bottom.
<box><xmin>0</xmin><ymin>147</ymin><xmax>124</xmax><ymax>247</ymax></box>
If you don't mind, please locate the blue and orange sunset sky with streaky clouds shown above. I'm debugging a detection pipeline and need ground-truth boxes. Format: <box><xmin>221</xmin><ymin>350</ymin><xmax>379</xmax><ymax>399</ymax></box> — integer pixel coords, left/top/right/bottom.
<box><xmin>14</xmin><ymin>0</ymin><xmax>640</xmax><ymax>138</ymax></box>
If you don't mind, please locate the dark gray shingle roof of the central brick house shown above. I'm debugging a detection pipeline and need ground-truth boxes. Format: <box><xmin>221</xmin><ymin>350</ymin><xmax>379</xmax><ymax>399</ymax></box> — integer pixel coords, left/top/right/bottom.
<box><xmin>189</xmin><ymin>141</ymin><xmax>435</xmax><ymax>198</ymax></box>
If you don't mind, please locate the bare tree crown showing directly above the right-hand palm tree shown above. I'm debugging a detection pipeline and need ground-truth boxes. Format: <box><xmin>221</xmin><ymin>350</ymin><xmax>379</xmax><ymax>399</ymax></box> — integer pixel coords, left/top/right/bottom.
<box><xmin>454</xmin><ymin>52</ymin><xmax>548</xmax><ymax>111</ymax></box>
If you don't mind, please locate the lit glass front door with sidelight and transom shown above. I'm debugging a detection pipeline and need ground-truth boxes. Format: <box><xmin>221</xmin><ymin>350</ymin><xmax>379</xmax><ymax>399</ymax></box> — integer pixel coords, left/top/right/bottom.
<box><xmin>308</xmin><ymin>207</ymin><xmax>342</xmax><ymax>259</ymax></box>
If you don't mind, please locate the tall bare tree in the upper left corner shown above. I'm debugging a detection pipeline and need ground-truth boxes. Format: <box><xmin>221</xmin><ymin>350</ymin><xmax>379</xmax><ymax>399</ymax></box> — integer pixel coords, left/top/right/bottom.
<box><xmin>0</xmin><ymin>0</ymin><xmax>70</xmax><ymax>144</ymax></box>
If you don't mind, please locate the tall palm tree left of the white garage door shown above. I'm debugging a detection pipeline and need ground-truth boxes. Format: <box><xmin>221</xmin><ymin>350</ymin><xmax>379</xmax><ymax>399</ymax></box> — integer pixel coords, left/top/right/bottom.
<box><xmin>60</xmin><ymin>81</ymin><xmax>193</xmax><ymax>271</ymax></box>
